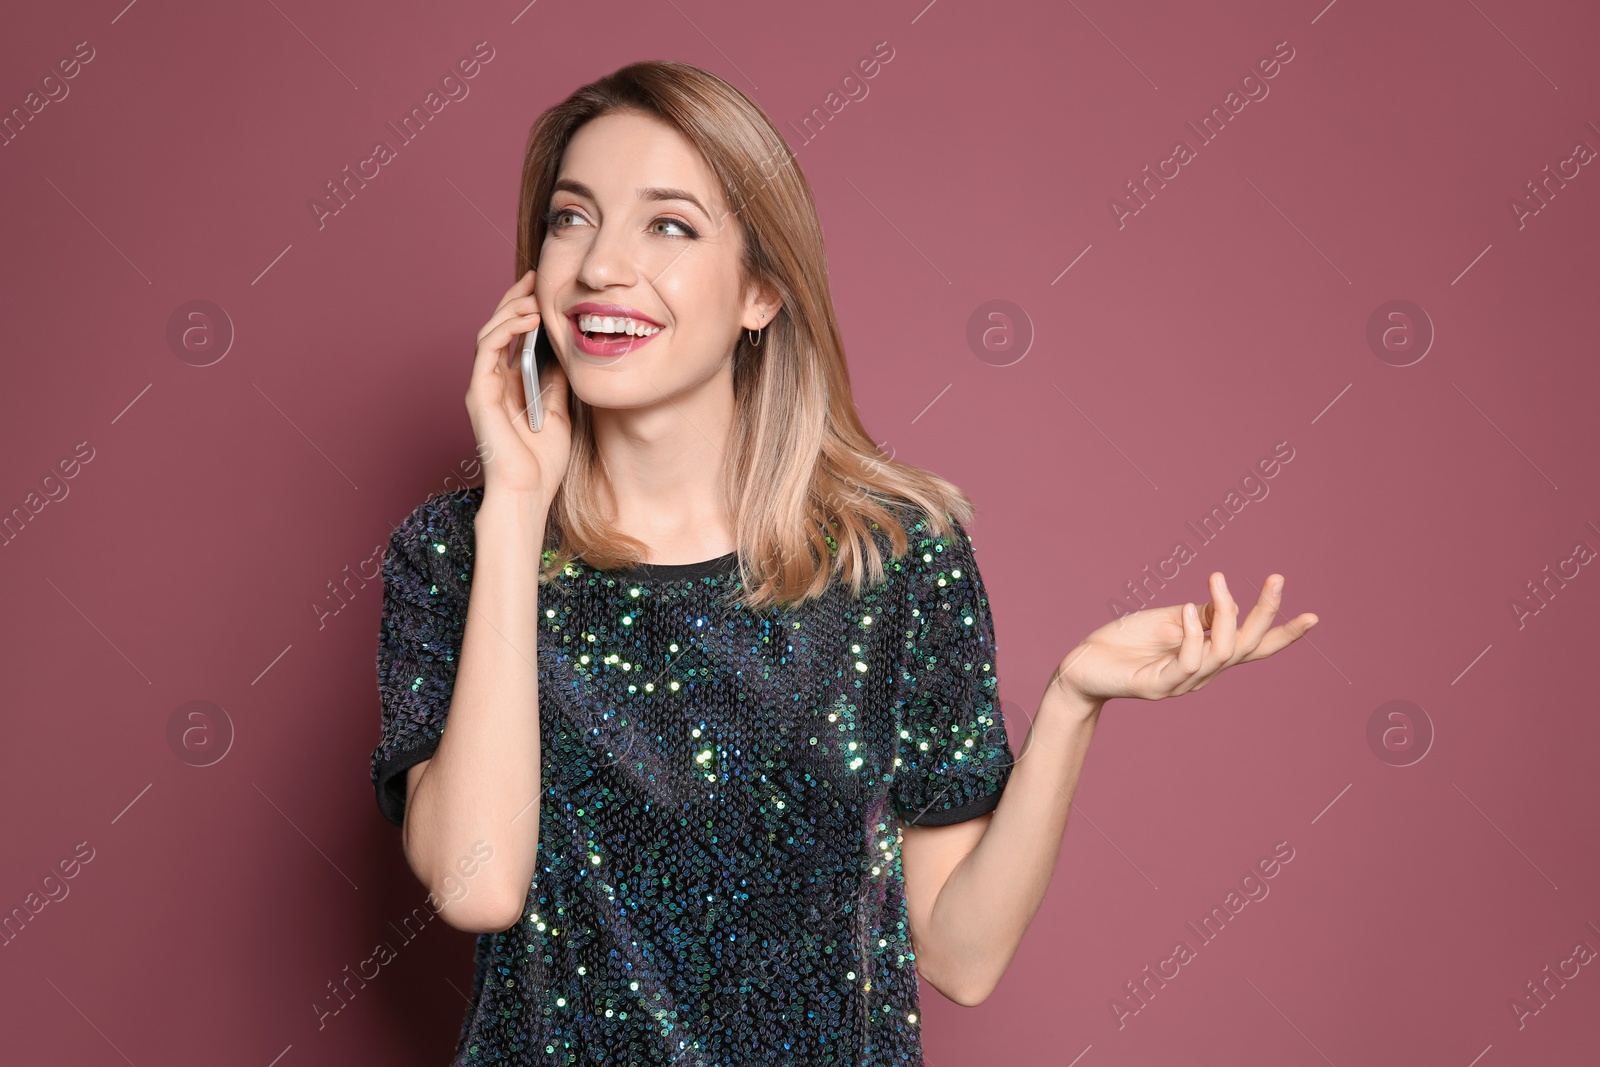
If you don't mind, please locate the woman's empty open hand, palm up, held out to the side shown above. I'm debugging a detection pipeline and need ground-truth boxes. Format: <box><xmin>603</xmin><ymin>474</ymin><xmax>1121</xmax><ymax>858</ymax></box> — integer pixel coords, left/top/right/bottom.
<box><xmin>1053</xmin><ymin>571</ymin><xmax>1317</xmax><ymax>702</ymax></box>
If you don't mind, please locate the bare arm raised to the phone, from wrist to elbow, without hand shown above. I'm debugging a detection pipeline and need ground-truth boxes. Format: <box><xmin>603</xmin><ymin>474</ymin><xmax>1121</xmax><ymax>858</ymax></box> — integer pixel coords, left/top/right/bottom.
<box><xmin>402</xmin><ymin>493</ymin><xmax>549</xmax><ymax>933</ymax></box>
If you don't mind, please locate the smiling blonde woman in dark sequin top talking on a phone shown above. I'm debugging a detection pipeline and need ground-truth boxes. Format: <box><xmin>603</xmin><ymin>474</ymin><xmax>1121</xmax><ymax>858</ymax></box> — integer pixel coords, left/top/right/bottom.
<box><xmin>373</xmin><ymin>62</ymin><xmax>1315</xmax><ymax>1067</ymax></box>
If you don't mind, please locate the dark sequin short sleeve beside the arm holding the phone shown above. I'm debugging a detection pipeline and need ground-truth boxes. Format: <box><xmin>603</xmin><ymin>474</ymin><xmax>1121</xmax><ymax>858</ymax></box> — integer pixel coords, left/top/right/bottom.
<box><xmin>371</xmin><ymin>490</ymin><xmax>474</xmax><ymax>825</ymax></box>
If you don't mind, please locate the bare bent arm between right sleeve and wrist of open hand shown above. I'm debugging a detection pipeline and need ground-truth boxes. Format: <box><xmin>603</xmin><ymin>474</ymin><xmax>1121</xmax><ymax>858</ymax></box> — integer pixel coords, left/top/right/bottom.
<box><xmin>901</xmin><ymin>685</ymin><xmax>1104</xmax><ymax>1006</ymax></box>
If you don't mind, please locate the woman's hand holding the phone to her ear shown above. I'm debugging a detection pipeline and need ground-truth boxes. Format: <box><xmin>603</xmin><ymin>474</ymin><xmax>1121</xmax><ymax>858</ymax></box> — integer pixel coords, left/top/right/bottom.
<box><xmin>467</xmin><ymin>270</ymin><xmax>573</xmax><ymax>507</ymax></box>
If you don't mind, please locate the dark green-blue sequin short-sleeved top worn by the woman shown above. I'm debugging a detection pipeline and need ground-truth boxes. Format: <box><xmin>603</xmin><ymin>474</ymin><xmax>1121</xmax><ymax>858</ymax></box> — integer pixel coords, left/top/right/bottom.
<box><xmin>371</xmin><ymin>486</ymin><xmax>1013</xmax><ymax>1067</ymax></box>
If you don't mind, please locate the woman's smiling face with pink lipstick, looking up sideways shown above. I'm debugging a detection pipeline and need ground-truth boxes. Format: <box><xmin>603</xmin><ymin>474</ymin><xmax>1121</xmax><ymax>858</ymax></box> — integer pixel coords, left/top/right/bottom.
<box><xmin>534</xmin><ymin>114</ymin><xmax>773</xmax><ymax>410</ymax></box>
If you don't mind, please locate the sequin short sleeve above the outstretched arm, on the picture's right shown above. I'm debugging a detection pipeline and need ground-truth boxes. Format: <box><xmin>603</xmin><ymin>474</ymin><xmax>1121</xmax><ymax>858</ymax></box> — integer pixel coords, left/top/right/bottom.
<box><xmin>893</xmin><ymin>517</ymin><xmax>1016</xmax><ymax>825</ymax></box>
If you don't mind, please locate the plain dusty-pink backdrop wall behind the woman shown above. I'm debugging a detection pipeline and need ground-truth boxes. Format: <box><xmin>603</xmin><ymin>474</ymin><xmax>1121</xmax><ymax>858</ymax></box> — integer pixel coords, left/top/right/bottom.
<box><xmin>0</xmin><ymin>0</ymin><xmax>1600</xmax><ymax>1067</ymax></box>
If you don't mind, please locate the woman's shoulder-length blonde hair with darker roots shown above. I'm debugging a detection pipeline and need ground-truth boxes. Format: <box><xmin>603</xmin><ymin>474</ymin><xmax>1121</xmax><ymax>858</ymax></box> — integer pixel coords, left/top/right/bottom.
<box><xmin>514</xmin><ymin>61</ymin><xmax>973</xmax><ymax>609</ymax></box>
